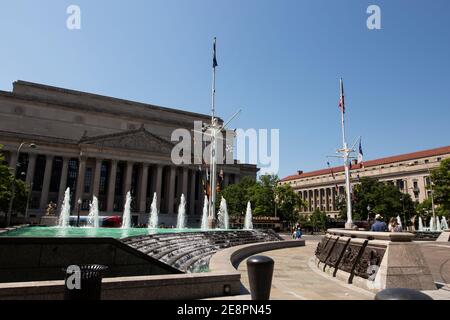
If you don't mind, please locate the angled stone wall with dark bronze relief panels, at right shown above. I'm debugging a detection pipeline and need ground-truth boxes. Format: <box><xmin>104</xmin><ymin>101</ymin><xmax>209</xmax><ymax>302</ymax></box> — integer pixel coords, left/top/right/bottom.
<box><xmin>316</xmin><ymin>229</ymin><xmax>436</xmax><ymax>292</ymax></box>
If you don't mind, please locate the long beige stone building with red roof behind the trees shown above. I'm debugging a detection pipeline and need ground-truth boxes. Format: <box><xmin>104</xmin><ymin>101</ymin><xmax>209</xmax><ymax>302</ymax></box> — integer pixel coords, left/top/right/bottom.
<box><xmin>280</xmin><ymin>146</ymin><xmax>450</xmax><ymax>218</ymax></box>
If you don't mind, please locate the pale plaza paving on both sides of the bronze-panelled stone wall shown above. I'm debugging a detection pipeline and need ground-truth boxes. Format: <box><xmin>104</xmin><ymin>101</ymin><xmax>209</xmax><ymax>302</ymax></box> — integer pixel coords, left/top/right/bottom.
<box><xmin>235</xmin><ymin>239</ymin><xmax>450</xmax><ymax>300</ymax></box>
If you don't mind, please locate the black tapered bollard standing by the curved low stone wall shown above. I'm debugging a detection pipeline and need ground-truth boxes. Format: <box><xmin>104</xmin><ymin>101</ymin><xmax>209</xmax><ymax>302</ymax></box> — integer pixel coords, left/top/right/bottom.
<box><xmin>247</xmin><ymin>256</ymin><xmax>275</xmax><ymax>300</ymax></box>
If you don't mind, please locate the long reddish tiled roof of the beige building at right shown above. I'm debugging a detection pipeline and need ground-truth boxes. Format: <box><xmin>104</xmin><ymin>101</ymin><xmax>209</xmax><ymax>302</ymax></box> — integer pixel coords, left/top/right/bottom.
<box><xmin>281</xmin><ymin>146</ymin><xmax>450</xmax><ymax>182</ymax></box>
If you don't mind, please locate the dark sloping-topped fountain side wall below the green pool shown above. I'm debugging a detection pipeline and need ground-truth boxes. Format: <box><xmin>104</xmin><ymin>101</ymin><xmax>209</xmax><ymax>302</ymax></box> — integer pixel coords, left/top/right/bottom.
<box><xmin>0</xmin><ymin>238</ymin><xmax>180</xmax><ymax>283</ymax></box>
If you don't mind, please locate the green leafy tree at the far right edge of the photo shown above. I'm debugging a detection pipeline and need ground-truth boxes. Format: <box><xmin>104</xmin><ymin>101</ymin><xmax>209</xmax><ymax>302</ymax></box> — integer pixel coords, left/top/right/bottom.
<box><xmin>431</xmin><ymin>158</ymin><xmax>450</xmax><ymax>216</ymax></box>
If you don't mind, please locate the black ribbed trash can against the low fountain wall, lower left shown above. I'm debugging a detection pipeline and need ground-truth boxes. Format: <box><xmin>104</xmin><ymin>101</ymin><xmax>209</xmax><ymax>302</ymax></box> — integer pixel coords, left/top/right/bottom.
<box><xmin>64</xmin><ymin>264</ymin><xmax>108</xmax><ymax>300</ymax></box>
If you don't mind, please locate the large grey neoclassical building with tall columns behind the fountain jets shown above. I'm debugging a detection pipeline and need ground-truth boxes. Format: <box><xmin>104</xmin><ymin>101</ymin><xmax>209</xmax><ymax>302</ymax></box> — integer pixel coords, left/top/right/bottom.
<box><xmin>0</xmin><ymin>81</ymin><xmax>258</xmax><ymax>225</ymax></box>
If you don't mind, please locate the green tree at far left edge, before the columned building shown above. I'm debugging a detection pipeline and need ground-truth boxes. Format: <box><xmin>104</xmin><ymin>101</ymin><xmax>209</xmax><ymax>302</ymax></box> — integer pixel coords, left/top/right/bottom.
<box><xmin>0</xmin><ymin>146</ymin><xmax>28</xmax><ymax>222</ymax></box>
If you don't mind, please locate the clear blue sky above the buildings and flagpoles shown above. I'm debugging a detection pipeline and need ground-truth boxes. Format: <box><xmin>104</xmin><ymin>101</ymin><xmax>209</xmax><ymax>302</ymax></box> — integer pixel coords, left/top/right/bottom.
<box><xmin>0</xmin><ymin>0</ymin><xmax>450</xmax><ymax>177</ymax></box>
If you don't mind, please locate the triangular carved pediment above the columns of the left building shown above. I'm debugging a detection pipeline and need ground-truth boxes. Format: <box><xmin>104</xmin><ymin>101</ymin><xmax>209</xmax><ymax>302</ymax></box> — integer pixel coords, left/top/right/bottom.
<box><xmin>80</xmin><ymin>127</ymin><xmax>174</xmax><ymax>155</ymax></box>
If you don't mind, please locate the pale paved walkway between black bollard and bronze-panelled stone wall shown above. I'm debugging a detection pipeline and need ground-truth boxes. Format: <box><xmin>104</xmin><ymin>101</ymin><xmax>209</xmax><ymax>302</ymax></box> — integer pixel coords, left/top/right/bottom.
<box><xmin>238</xmin><ymin>240</ymin><xmax>374</xmax><ymax>300</ymax></box>
